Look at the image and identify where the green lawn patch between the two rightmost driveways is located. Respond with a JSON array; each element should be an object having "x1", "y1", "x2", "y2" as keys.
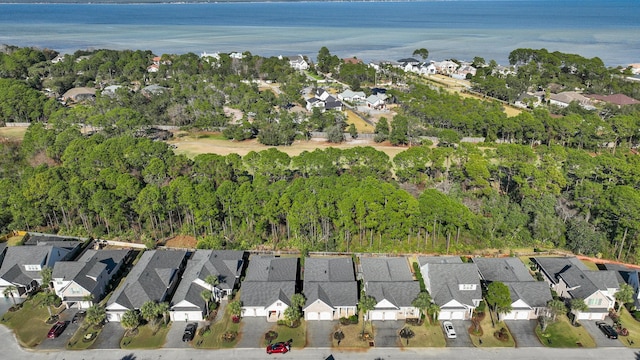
[{"x1": 536, "y1": 315, "x2": 596, "y2": 348}]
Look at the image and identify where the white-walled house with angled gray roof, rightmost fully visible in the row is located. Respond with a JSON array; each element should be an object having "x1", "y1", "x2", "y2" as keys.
[{"x1": 533, "y1": 257, "x2": 620, "y2": 320}]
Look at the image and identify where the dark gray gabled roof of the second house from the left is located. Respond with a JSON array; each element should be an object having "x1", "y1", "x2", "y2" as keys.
[{"x1": 52, "y1": 249, "x2": 130, "y2": 293}]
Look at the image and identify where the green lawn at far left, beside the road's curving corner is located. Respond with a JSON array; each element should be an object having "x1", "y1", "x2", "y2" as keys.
[{"x1": 2, "y1": 293, "x2": 58, "y2": 348}]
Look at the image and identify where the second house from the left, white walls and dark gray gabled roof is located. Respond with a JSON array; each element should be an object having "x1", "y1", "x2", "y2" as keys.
[{"x1": 52, "y1": 249, "x2": 131, "y2": 309}]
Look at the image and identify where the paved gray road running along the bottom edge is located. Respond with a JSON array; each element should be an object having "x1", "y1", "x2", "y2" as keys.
[{"x1": 0, "y1": 326, "x2": 640, "y2": 360}]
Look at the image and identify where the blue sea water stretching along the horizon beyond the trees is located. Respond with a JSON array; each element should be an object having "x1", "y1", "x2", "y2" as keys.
[{"x1": 0, "y1": 0, "x2": 640, "y2": 66}]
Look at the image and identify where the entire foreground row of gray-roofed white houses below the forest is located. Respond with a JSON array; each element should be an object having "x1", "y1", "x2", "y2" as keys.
[{"x1": 0, "y1": 234, "x2": 638, "y2": 322}]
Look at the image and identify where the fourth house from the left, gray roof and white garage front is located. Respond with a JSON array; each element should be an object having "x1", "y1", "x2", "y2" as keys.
[{"x1": 170, "y1": 250, "x2": 246, "y2": 321}]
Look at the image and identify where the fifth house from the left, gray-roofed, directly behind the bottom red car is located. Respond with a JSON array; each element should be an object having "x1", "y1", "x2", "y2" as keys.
[{"x1": 240, "y1": 255, "x2": 299, "y2": 322}]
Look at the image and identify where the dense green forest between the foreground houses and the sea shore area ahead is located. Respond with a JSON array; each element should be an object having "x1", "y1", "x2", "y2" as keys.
[{"x1": 0, "y1": 48, "x2": 640, "y2": 262}]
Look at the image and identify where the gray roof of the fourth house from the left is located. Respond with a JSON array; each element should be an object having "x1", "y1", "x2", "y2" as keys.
[{"x1": 171, "y1": 250, "x2": 245, "y2": 309}]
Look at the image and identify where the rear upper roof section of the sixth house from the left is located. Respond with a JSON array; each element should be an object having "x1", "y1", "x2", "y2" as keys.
[{"x1": 304, "y1": 257, "x2": 356, "y2": 282}]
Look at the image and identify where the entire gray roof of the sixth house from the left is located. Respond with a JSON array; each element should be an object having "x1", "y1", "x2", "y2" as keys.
[{"x1": 303, "y1": 257, "x2": 358, "y2": 308}]
